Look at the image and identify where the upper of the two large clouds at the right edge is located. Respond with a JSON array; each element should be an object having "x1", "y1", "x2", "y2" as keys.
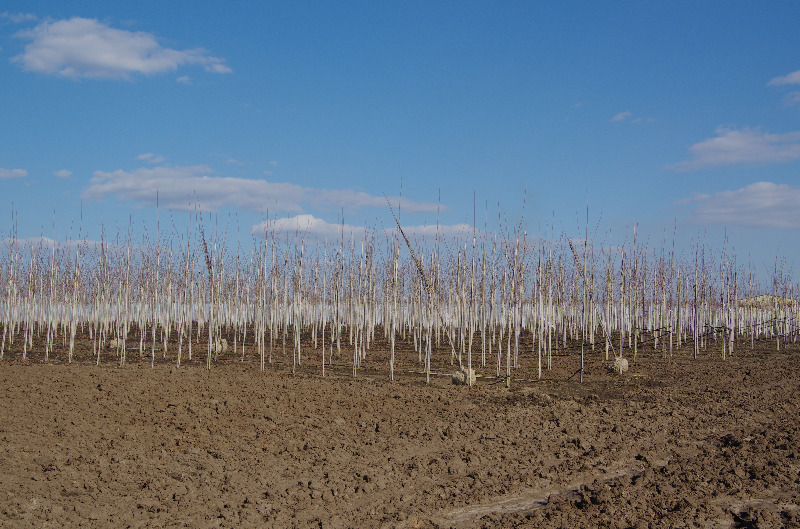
[{"x1": 669, "y1": 127, "x2": 800, "y2": 171}]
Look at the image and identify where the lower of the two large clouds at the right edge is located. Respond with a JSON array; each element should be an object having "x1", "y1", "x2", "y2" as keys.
[{"x1": 691, "y1": 182, "x2": 800, "y2": 229}]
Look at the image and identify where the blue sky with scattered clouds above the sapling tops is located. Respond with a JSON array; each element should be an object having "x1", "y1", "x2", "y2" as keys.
[{"x1": 0, "y1": 1, "x2": 800, "y2": 276}]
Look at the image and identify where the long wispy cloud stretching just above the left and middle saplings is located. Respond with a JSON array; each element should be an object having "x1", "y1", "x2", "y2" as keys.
[{"x1": 83, "y1": 165, "x2": 446, "y2": 214}]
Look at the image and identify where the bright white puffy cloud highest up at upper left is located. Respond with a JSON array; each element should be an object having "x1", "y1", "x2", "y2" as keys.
[{"x1": 11, "y1": 17, "x2": 231, "y2": 79}]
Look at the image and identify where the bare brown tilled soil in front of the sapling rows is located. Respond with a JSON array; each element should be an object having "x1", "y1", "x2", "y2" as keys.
[{"x1": 0, "y1": 328, "x2": 800, "y2": 528}]
